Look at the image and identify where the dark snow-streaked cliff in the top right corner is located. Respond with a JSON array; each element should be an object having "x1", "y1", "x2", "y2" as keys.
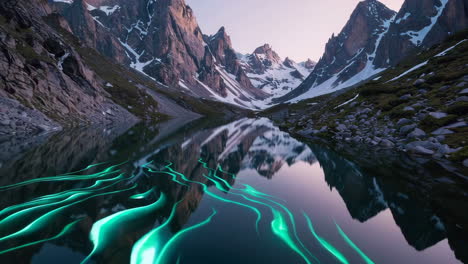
[{"x1": 376, "y1": 0, "x2": 468, "y2": 67}]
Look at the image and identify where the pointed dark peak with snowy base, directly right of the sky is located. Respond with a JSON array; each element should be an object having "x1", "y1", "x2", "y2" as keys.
[{"x1": 281, "y1": 0, "x2": 396, "y2": 100}]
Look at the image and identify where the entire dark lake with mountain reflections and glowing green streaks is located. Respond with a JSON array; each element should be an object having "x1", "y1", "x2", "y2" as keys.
[{"x1": 0, "y1": 119, "x2": 468, "y2": 263}]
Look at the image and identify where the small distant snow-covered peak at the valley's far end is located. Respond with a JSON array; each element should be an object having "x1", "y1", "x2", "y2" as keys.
[{"x1": 239, "y1": 44, "x2": 315, "y2": 100}]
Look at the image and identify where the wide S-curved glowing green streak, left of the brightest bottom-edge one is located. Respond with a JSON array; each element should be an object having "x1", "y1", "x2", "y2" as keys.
[{"x1": 82, "y1": 192, "x2": 167, "y2": 263}]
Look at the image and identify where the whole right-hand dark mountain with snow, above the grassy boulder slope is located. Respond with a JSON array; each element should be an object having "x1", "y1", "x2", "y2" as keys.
[{"x1": 276, "y1": 0, "x2": 468, "y2": 102}]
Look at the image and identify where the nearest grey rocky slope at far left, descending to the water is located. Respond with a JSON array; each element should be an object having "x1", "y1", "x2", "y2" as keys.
[{"x1": 0, "y1": 1, "x2": 137, "y2": 136}]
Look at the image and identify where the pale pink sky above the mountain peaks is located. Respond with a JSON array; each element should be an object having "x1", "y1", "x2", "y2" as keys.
[{"x1": 186, "y1": 0, "x2": 403, "y2": 62}]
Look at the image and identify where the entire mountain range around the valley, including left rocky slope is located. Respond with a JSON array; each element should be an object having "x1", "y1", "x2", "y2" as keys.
[{"x1": 0, "y1": 0, "x2": 468, "y2": 132}]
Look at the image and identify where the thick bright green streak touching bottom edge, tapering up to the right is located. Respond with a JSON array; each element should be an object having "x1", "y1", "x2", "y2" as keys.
[{"x1": 130, "y1": 201, "x2": 182, "y2": 264}]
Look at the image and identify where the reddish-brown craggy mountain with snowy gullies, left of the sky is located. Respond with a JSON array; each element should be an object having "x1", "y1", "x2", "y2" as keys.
[{"x1": 49, "y1": 0, "x2": 267, "y2": 108}]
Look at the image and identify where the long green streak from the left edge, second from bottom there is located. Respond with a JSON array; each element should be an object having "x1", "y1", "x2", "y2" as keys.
[{"x1": 0, "y1": 184, "x2": 137, "y2": 242}]
